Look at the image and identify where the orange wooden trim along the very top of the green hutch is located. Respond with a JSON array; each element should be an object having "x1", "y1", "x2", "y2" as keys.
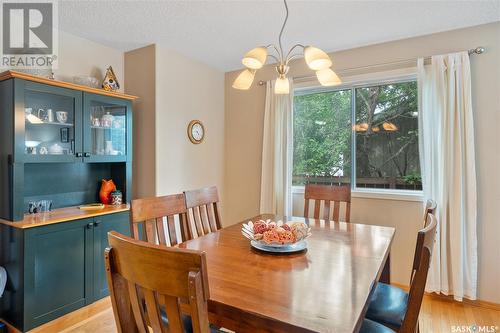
[{"x1": 0, "y1": 71, "x2": 138, "y2": 101}]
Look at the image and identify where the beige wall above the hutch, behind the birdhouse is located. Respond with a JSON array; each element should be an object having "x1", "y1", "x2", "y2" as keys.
[{"x1": 54, "y1": 31, "x2": 125, "y2": 91}]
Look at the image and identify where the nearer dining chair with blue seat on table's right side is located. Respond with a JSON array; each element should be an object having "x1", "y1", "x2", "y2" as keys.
[{"x1": 366, "y1": 214, "x2": 437, "y2": 333}]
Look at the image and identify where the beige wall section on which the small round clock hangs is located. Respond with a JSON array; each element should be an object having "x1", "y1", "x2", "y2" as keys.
[{"x1": 156, "y1": 47, "x2": 224, "y2": 194}]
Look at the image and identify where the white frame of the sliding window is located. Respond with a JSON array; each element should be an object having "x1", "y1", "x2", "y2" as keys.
[{"x1": 291, "y1": 68, "x2": 423, "y2": 201}]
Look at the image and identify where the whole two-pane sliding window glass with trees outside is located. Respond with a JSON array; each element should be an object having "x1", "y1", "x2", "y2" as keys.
[{"x1": 292, "y1": 80, "x2": 422, "y2": 190}]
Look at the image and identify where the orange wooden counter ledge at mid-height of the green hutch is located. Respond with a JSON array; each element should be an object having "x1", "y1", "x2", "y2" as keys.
[{"x1": 0, "y1": 205, "x2": 130, "y2": 229}]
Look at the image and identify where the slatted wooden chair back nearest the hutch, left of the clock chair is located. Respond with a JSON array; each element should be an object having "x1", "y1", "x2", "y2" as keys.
[{"x1": 130, "y1": 193, "x2": 191, "y2": 246}]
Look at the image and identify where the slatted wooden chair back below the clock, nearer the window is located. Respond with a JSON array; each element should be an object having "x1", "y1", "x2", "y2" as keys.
[{"x1": 184, "y1": 186, "x2": 222, "y2": 238}]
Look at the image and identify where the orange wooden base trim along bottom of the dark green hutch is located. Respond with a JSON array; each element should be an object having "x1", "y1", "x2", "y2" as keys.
[{"x1": 0, "y1": 296, "x2": 111, "y2": 333}]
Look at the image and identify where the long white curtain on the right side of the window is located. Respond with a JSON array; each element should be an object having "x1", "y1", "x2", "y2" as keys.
[{"x1": 418, "y1": 52, "x2": 477, "y2": 300}]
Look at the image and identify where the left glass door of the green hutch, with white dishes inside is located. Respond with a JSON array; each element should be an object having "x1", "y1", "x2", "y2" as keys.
[{"x1": 22, "y1": 82, "x2": 82, "y2": 163}]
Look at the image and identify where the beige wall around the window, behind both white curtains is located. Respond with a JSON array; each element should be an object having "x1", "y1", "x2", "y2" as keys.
[{"x1": 224, "y1": 23, "x2": 500, "y2": 303}]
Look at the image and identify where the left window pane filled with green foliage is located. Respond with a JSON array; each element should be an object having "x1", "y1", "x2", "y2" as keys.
[{"x1": 292, "y1": 89, "x2": 352, "y2": 185}]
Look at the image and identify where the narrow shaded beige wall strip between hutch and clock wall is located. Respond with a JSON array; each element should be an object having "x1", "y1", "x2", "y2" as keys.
[{"x1": 125, "y1": 45, "x2": 156, "y2": 198}]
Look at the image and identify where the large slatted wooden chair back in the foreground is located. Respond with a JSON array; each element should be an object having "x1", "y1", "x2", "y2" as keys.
[{"x1": 104, "y1": 231, "x2": 210, "y2": 333}]
